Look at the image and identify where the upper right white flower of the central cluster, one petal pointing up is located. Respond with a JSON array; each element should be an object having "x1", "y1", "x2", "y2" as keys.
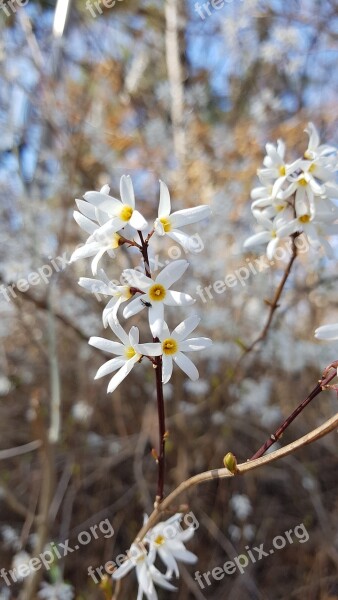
[{"x1": 154, "y1": 181, "x2": 211, "y2": 252}]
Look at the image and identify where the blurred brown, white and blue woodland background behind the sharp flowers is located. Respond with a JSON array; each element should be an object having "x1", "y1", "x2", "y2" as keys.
[{"x1": 0, "y1": 0, "x2": 338, "y2": 600}]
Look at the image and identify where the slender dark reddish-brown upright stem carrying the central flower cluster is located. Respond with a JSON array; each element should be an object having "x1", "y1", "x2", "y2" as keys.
[{"x1": 138, "y1": 231, "x2": 166, "y2": 506}]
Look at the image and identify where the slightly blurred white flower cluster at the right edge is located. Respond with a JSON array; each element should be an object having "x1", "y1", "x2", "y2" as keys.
[{"x1": 244, "y1": 123, "x2": 338, "y2": 260}]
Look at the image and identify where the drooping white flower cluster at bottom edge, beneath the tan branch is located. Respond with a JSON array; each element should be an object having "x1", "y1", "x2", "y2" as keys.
[{"x1": 113, "y1": 513, "x2": 197, "y2": 600}]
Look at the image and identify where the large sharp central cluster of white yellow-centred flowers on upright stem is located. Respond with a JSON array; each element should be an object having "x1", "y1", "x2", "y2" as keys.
[{"x1": 71, "y1": 175, "x2": 211, "y2": 392}]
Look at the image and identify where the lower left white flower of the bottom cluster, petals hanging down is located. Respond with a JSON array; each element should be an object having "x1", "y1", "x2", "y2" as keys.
[{"x1": 112, "y1": 544, "x2": 176, "y2": 600}]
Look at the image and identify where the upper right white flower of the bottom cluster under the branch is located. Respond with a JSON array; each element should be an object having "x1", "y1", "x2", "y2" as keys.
[{"x1": 145, "y1": 513, "x2": 197, "y2": 578}]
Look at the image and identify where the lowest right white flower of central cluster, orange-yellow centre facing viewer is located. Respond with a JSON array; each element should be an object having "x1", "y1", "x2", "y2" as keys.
[{"x1": 159, "y1": 315, "x2": 212, "y2": 383}]
